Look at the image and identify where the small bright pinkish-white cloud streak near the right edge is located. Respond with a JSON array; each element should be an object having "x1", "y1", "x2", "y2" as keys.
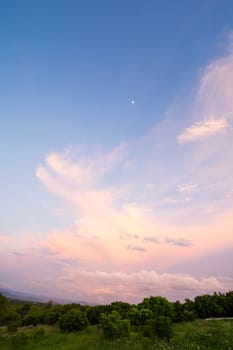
[{"x1": 177, "y1": 118, "x2": 230, "y2": 143}]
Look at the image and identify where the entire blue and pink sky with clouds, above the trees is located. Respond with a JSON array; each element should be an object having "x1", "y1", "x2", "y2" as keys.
[{"x1": 0, "y1": 0, "x2": 233, "y2": 303}]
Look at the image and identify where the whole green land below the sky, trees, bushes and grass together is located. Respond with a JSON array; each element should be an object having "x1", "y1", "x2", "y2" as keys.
[{"x1": 0, "y1": 291, "x2": 233, "y2": 350}]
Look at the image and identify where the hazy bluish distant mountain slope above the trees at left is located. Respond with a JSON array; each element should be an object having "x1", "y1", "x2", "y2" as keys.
[{"x1": 0, "y1": 287, "x2": 88, "y2": 305}]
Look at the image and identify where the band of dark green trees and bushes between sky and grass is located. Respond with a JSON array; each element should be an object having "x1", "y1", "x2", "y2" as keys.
[{"x1": 0, "y1": 291, "x2": 233, "y2": 339}]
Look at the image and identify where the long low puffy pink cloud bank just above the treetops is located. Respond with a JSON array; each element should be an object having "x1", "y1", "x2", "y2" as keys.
[{"x1": 55, "y1": 269, "x2": 225, "y2": 303}]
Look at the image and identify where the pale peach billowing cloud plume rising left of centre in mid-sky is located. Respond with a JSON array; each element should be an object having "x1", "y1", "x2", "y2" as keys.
[{"x1": 37, "y1": 148, "x2": 166, "y2": 256}]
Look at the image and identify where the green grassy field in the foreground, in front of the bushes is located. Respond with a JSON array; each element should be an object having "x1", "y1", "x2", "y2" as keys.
[{"x1": 0, "y1": 320, "x2": 233, "y2": 350}]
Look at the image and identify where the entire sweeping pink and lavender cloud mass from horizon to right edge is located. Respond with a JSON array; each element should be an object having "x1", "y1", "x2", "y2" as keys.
[{"x1": 0, "y1": 36, "x2": 233, "y2": 302}]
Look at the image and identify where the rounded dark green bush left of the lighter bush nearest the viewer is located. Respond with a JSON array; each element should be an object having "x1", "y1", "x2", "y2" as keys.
[{"x1": 59, "y1": 309, "x2": 89, "y2": 332}]
